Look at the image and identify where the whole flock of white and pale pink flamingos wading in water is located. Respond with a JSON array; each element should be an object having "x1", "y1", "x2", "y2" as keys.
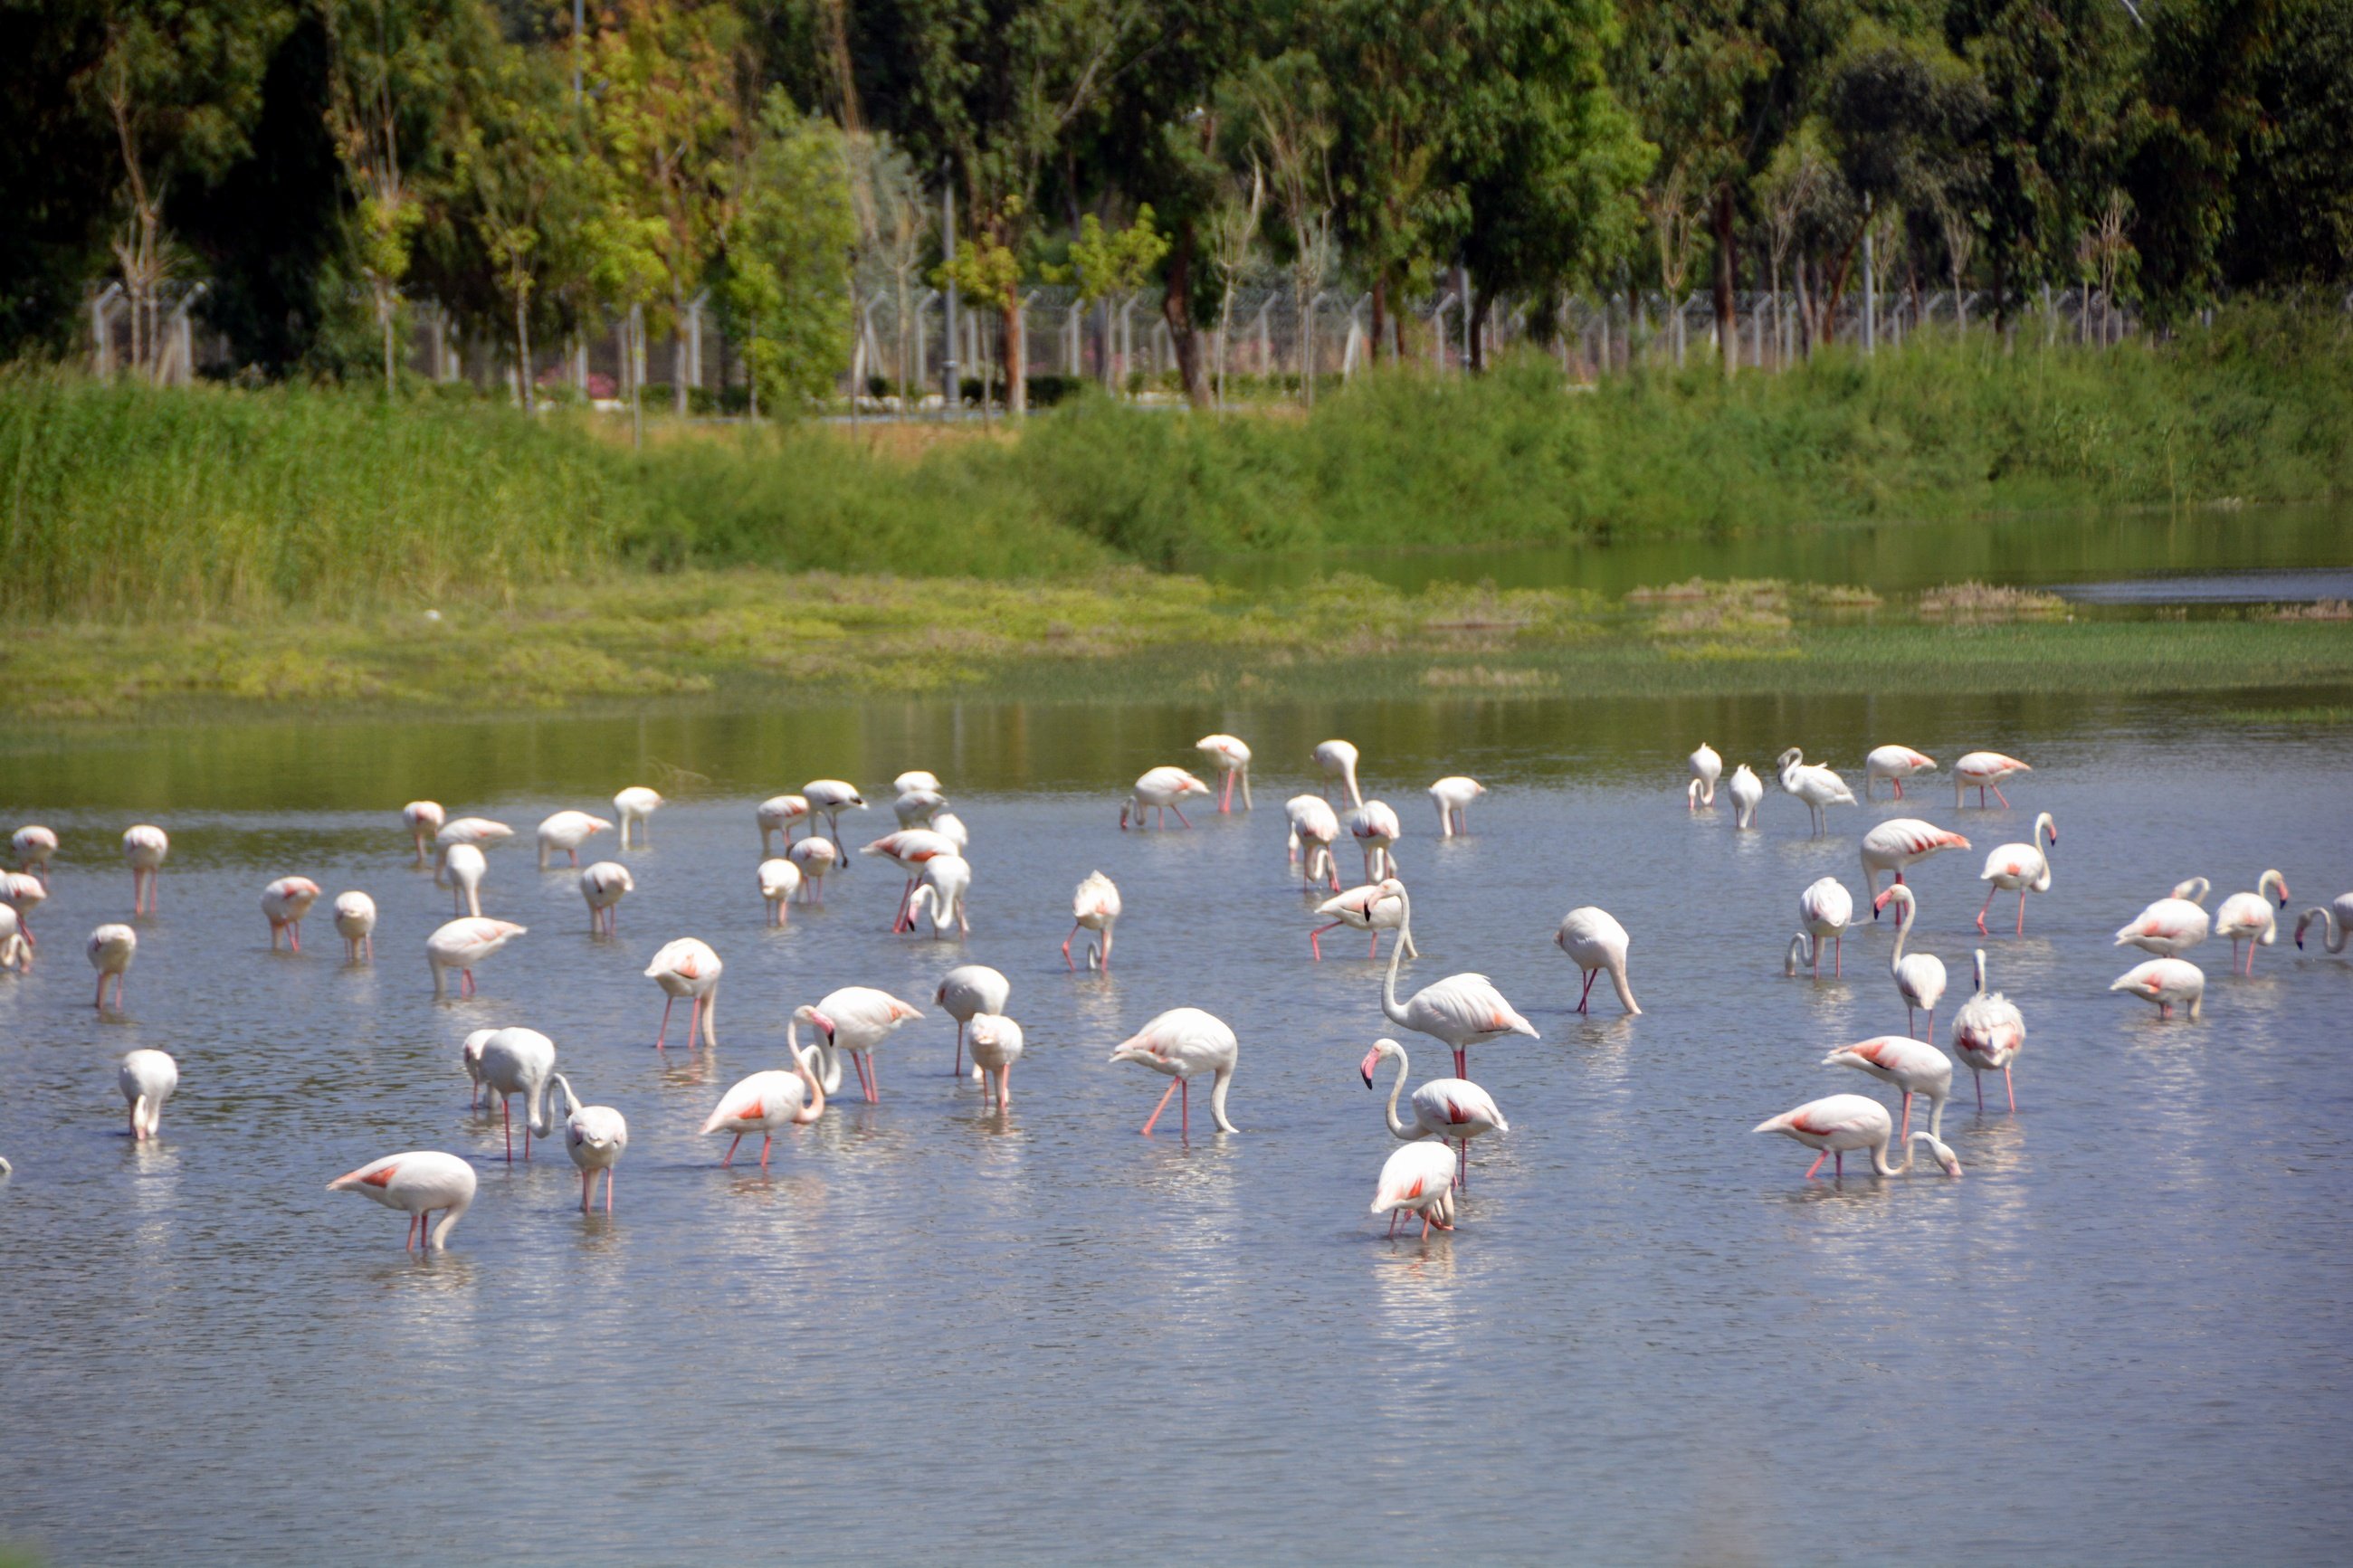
[{"x1": 0, "y1": 736, "x2": 2353, "y2": 1250}]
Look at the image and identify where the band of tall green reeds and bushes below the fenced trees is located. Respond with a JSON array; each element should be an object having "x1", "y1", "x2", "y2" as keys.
[{"x1": 0, "y1": 310, "x2": 2353, "y2": 623}]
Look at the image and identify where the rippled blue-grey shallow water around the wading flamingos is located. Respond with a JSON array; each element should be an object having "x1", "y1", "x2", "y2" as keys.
[{"x1": 0, "y1": 700, "x2": 2353, "y2": 1563}]
